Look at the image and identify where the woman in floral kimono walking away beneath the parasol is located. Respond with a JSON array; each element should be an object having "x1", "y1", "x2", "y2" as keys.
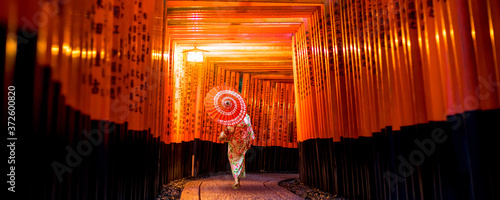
[{"x1": 219, "y1": 114, "x2": 255, "y2": 189}]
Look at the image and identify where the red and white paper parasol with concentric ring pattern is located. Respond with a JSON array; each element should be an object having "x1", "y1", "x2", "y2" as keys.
[{"x1": 205, "y1": 86, "x2": 247, "y2": 126}]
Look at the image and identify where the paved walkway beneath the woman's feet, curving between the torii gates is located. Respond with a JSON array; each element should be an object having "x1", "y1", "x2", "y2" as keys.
[{"x1": 181, "y1": 174, "x2": 301, "y2": 200}]
